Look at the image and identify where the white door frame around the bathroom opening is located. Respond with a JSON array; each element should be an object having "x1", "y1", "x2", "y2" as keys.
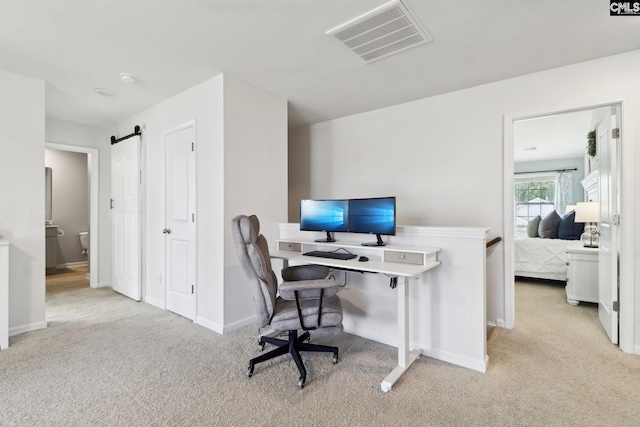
[{"x1": 44, "y1": 141, "x2": 100, "y2": 288}]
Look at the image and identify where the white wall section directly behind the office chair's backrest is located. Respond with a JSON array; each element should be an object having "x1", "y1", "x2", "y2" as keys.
[{"x1": 221, "y1": 78, "x2": 288, "y2": 330}]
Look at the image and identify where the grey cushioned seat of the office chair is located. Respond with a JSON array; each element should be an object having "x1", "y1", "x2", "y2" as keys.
[{"x1": 271, "y1": 296, "x2": 342, "y2": 335}]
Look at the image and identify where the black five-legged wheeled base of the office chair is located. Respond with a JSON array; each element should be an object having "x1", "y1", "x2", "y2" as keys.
[{"x1": 247, "y1": 331, "x2": 338, "y2": 388}]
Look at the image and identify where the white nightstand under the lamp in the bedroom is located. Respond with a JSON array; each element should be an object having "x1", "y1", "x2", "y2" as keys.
[{"x1": 566, "y1": 244, "x2": 598, "y2": 305}]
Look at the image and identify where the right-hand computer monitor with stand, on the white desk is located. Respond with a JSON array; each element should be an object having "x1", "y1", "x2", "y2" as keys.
[{"x1": 349, "y1": 197, "x2": 396, "y2": 246}]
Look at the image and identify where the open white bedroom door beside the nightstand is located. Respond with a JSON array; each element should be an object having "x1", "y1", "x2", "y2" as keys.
[{"x1": 597, "y1": 107, "x2": 620, "y2": 344}]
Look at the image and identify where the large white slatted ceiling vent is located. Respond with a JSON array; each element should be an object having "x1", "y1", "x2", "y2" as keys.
[{"x1": 325, "y1": 0, "x2": 431, "y2": 62}]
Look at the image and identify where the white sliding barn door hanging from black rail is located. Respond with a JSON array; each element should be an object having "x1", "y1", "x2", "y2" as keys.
[{"x1": 111, "y1": 136, "x2": 142, "y2": 301}]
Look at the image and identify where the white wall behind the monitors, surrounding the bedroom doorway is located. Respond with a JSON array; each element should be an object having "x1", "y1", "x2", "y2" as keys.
[{"x1": 289, "y1": 51, "x2": 640, "y2": 343}]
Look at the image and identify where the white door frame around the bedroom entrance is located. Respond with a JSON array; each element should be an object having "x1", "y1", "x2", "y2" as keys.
[{"x1": 499, "y1": 93, "x2": 635, "y2": 353}]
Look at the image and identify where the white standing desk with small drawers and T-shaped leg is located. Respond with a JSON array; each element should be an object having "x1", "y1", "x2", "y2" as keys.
[{"x1": 271, "y1": 239, "x2": 440, "y2": 393}]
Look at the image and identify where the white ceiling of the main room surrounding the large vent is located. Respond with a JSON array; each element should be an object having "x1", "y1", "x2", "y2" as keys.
[{"x1": 0, "y1": 0, "x2": 640, "y2": 128}]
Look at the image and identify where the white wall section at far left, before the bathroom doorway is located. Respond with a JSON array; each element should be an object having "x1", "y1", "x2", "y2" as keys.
[{"x1": 0, "y1": 70, "x2": 46, "y2": 335}]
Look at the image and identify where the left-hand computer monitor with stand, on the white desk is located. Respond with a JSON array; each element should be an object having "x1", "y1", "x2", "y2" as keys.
[{"x1": 300, "y1": 199, "x2": 349, "y2": 242}]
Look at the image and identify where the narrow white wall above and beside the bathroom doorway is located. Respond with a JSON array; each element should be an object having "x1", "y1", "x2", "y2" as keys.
[{"x1": 43, "y1": 118, "x2": 113, "y2": 286}]
